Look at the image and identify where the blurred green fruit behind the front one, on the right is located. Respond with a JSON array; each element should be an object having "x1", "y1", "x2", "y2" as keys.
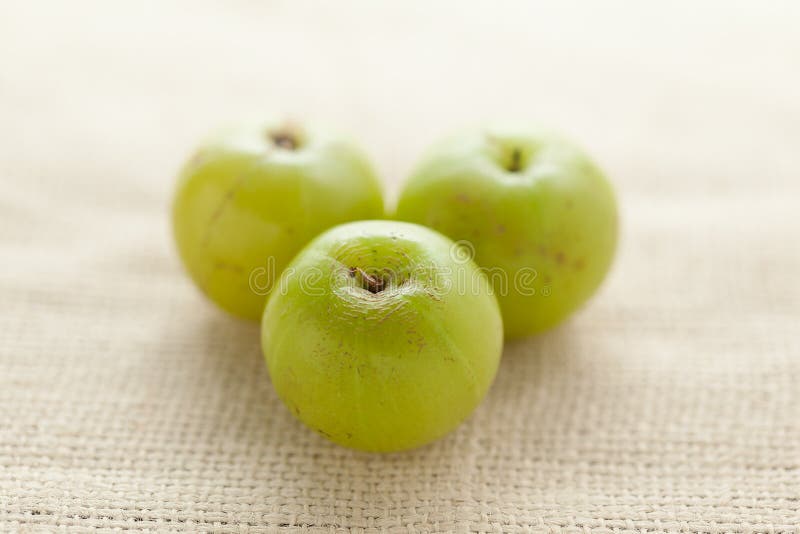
[{"x1": 397, "y1": 129, "x2": 617, "y2": 338}]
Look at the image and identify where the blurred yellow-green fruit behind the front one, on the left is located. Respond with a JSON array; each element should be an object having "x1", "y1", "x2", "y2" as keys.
[{"x1": 172, "y1": 124, "x2": 384, "y2": 320}]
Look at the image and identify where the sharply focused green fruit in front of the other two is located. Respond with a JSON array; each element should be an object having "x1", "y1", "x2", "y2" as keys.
[{"x1": 262, "y1": 221, "x2": 503, "y2": 452}]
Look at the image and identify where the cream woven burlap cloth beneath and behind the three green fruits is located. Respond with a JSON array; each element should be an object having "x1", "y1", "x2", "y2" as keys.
[{"x1": 0, "y1": 1, "x2": 800, "y2": 534}]
